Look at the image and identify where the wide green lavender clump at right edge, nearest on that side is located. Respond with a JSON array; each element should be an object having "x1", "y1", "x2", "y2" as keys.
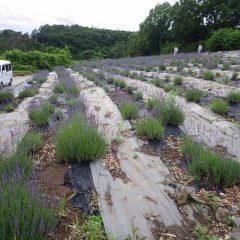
[{"x1": 182, "y1": 136, "x2": 240, "y2": 187}]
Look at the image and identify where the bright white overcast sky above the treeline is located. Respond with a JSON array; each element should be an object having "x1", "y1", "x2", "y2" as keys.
[{"x1": 0, "y1": 0, "x2": 176, "y2": 33}]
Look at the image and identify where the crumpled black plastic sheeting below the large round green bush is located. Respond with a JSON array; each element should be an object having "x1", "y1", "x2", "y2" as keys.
[{"x1": 64, "y1": 162, "x2": 95, "y2": 215}]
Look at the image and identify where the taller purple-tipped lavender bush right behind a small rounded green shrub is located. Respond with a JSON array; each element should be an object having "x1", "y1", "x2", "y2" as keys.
[{"x1": 153, "y1": 98, "x2": 185, "y2": 126}]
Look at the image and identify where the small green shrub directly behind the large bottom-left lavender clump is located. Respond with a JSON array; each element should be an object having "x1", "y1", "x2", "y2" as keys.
[{"x1": 17, "y1": 132, "x2": 43, "y2": 156}]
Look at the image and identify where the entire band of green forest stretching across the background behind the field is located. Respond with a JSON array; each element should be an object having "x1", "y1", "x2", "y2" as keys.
[{"x1": 0, "y1": 0, "x2": 240, "y2": 60}]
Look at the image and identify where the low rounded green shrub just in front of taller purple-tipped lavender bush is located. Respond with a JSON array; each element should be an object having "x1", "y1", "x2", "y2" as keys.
[{"x1": 135, "y1": 118, "x2": 164, "y2": 140}]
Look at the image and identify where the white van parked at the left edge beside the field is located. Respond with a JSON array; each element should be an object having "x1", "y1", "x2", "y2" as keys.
[{"x1": 0, "y1": 60, "x2": 13, "y2": 89}]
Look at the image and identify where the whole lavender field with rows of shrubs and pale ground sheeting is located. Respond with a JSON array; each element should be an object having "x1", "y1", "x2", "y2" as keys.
[{"x1": 0, "y1": 51, "x2": 240, "y2": 240}]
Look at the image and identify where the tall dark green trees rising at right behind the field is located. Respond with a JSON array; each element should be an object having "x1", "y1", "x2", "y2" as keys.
[{"x1": 128, "y1": 0, "x2": 240, "y2": 56}]
